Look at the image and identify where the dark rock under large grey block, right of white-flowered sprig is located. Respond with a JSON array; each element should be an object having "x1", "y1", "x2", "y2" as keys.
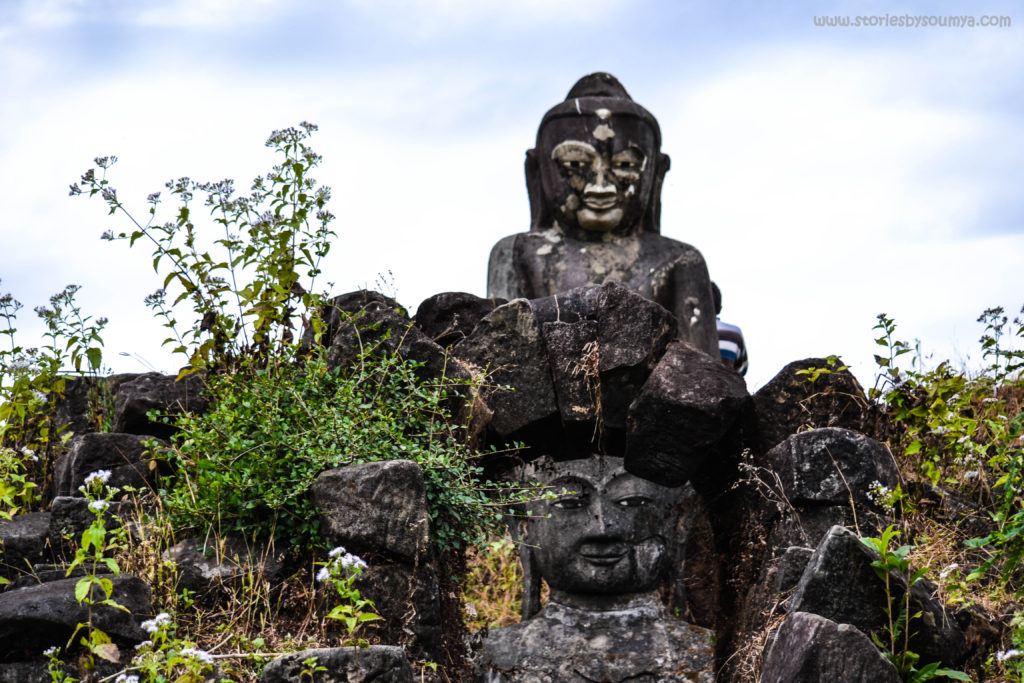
[{"x1": 356, "y1": 560, "x2": 442, "y2": 661}]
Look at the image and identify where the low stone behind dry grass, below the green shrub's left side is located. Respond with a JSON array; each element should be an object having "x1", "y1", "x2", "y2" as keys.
[{"x1": 164, "y1": 535, "x2": 284, "y2": 595}]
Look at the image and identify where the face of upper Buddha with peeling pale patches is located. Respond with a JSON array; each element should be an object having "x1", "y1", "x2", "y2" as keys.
[{"x1": 538, "y1": 113, "x2": 657, "y2": 233}]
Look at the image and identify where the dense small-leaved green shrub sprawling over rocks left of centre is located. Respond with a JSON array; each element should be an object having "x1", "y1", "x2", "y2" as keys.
[{"x1": 166, "y1": 342, "x2": 512, "y2": 548}]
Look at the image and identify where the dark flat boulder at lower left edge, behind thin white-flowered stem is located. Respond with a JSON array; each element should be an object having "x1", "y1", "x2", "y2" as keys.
[{"x1": 0, "y1": 574, "x2": 153, "y2": 660}]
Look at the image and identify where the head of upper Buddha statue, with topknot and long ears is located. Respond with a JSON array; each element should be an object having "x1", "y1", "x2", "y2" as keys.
[{"x1": 526, "y1": 73, "x2": 669, "y2": 238}]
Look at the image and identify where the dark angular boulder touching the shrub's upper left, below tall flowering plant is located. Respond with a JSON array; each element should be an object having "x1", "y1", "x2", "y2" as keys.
[{"x1": 113, "y1": 373, "x2": 210, "y2": 438}]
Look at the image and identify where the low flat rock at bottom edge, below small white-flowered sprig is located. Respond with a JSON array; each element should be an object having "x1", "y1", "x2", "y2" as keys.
[{"x1": 260, "y1": 645, "x2": 413, "y2": 683}]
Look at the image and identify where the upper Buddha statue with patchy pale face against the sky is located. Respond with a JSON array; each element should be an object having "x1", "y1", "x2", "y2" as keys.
[{"x1": 487, "y1": 74, "x2": 719, "y2": 356}]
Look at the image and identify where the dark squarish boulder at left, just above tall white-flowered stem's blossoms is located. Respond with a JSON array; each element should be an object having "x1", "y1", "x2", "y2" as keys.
[{"x1": 53, "y1": 433, "x2": 164, "y2": 496}]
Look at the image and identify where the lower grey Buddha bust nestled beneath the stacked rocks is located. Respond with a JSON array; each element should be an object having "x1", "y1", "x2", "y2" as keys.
[{"x1": 478, "y1": 456, "x2": 714, "y2": 683}]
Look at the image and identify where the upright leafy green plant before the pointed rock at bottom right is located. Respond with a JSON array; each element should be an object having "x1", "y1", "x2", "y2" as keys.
[{"x1": 860, "y1": 524, "x2": 971, "y2": 683}]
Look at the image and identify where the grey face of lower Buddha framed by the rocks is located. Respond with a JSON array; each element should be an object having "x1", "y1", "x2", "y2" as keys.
[{"x1": 526, "y1": 456, "x2": 678, "y2": 595}]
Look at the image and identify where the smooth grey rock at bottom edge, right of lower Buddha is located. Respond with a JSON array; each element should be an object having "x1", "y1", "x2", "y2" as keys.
[{"x1": 761, "y1": 612, "x2": 902, "y2": 683}]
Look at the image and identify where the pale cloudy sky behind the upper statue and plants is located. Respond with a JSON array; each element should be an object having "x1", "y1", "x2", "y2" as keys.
[{"x1": 0, "y1": 0, "x2": 1024, "y2": 390}]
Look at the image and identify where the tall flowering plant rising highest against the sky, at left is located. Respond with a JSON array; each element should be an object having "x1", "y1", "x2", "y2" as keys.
[{"x1": 71, "y1": 123, "x2": 334, "y2": 369}]
